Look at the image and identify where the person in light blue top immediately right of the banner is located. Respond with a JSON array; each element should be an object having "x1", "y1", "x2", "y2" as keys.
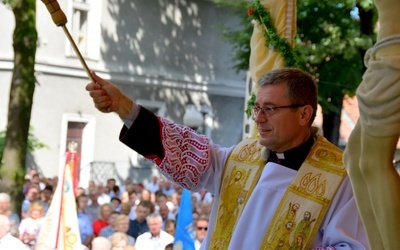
[{"x1": 76, "y1": 194, "x2": 94, "y2": 247}]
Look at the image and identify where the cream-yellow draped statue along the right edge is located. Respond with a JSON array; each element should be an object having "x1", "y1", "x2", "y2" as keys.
[{"x1": 345, "y1": 0, "x2": 400, "y2": 249}]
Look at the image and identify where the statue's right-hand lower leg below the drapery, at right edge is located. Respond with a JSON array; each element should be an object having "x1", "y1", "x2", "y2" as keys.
[{"x1": 360, "y1": 130, "x2": 400, "y2": 249}]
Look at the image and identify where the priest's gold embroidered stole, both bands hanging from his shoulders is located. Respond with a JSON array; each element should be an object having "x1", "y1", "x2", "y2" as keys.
[{"x1": 210, "y1": 130, "x2": 346, "y2": 249}]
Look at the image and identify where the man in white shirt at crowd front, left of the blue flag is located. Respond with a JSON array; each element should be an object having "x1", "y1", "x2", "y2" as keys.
[{"x1": 135, "y1": 213, "x2": 174, "y2": 250}]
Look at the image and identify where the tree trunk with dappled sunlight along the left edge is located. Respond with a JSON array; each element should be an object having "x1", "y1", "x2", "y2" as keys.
[{"x1": 0, "y1": 0, "x2": 37, "y2": 211}]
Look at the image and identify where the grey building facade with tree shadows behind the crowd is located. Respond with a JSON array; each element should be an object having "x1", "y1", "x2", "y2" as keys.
[{"x1": 0, "y1": 0, "x2": 246, "y2": 187}]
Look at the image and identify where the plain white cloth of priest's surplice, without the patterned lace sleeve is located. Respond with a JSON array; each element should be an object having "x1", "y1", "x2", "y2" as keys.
[{"x1": 188, "y1": 144, "x2": 369, "y2": 250}]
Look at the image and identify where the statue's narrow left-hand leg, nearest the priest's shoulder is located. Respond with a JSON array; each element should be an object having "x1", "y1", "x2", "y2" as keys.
[{"x1": 344, "y1": 122, "x2": 384, "y2": 250}]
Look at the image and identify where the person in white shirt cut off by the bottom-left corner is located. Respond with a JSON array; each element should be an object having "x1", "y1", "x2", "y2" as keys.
[{"x1": 0, "y1": 214, "x2": 29, "y2": 250}]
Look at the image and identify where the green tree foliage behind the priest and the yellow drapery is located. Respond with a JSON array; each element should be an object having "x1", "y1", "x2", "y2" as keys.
[{"x1": 219, "y1": 0, "x2": 376, "y2": 144}]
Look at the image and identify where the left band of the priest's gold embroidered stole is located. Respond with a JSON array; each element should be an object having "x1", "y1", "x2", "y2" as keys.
[{"x1": 210, "y1": 139, "x2": 268, "y2": 249}]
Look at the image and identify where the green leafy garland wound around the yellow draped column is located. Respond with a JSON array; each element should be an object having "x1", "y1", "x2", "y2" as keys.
[{"x1": 245, "y1": 0, "x2": 297, "y2": 117}]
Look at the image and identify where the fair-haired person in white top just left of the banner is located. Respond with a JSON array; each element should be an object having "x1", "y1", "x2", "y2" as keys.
[{"x1": 18, "y1": 201, "x2": 44, "y2": 249}]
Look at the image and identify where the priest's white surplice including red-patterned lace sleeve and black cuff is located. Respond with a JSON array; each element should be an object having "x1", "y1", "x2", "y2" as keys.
[{"x1": 120, "y1": 114, "x2": 369, "y2": 250}]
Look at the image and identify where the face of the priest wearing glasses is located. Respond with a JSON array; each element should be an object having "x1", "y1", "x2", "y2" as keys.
[{"x1": 253, "y1": 83, "x2": 310, "y2": 153}]
